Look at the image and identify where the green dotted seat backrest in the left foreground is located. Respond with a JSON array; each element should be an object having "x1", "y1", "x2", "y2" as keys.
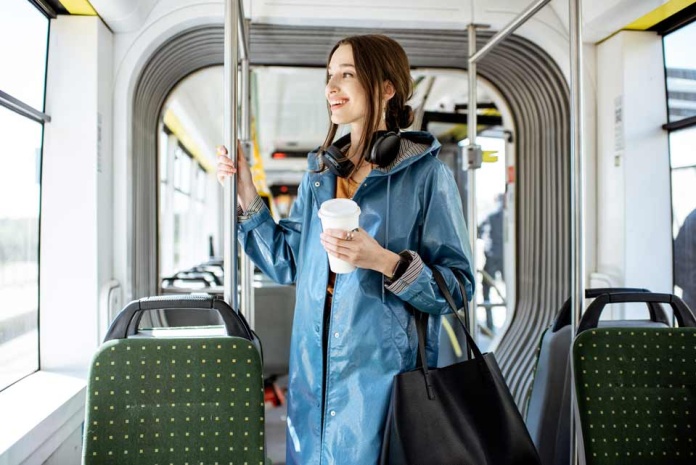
[{"x1": 83, "y1": 297, "x2": 266, "y2": 465}]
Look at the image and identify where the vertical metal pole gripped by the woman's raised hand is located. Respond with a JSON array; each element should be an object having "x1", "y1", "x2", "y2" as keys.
[{"x1": 223, "y1": 0, "x2": 240, "y2": 310}]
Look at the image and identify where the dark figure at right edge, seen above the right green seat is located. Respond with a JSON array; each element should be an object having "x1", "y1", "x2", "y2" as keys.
[{"x1": 674, "y1": 209, "x2": 696, "y2": 311}]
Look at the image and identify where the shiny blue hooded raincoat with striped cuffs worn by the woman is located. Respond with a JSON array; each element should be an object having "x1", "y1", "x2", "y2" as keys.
[{"x1": 239, "y1": 132, "x2": 473, "y2": 465}]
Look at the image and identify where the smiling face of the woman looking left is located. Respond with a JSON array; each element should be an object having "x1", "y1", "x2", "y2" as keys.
[{"x1": 325, "y1": 44, "x2": 367, "y2": 130}]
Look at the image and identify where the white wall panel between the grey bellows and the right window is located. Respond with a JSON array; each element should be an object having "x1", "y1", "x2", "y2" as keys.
[{"x1": 596, "y1": 31, "x2": 672, "y2": 302}]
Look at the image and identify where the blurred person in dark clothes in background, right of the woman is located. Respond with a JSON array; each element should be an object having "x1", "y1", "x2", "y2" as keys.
[{"x1": 477, "y1": 194, "x2": 505, "y2": 331}]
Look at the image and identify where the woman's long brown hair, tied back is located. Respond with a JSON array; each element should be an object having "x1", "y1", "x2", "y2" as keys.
[{"x1": 321, "y1": 34, "x2": 413, "y2": 171}]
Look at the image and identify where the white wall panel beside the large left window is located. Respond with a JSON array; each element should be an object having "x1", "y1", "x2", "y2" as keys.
[{"x1": 40, "y1": 16, "x2": 112, "y2": 371}]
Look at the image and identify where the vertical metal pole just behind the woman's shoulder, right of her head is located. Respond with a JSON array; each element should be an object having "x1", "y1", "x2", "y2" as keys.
[{"x1": 466, "y1": 23, "x2": 481, "y2": 341}]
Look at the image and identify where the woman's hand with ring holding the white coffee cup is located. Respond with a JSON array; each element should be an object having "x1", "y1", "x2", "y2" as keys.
[{"x1": 321, "y1": 228, "x2": 399, "y2": 278}]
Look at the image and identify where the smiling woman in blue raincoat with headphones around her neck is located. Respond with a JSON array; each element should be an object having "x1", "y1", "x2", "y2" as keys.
[{"x1": 218, "y1": 35, "x2": 474, "y2": 465}]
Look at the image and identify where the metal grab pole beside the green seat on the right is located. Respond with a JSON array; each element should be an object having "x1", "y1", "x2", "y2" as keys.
[{"x1": 570, "y1": 0, "x2": 585, "y2": 464}]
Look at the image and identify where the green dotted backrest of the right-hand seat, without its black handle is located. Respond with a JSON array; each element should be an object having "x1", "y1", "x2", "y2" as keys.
[{"x1": 573, "y1": 327, "x2": 696, "y2": 465}]
